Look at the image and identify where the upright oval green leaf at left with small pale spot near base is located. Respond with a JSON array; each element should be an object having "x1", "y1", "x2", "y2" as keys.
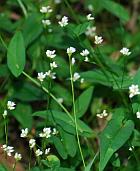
[{"x1": 7, "y1": 32, "x2": 25, "y2": 77}]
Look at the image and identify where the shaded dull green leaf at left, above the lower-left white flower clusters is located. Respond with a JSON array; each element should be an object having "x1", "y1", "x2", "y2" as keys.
[{"x1": 12, "y1": 103, "x2": 32, "y2": 128}]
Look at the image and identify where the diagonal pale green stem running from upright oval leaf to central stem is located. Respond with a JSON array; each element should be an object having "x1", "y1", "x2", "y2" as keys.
[{"x1": 22, "y1": 71, "x2": 74, "y2": 122}]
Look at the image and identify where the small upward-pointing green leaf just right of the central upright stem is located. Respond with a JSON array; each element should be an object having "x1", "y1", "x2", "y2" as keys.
[{"x1": 75, "y1": 87, "x2": 93, "y2": 117}]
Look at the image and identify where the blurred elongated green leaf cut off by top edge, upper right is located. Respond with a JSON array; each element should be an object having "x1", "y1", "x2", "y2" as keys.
[{"x1": 102, "y1": 0, "x2": 130, "y2": 22}]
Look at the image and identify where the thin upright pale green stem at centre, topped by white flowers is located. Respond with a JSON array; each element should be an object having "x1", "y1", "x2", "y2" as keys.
[{"x1": 68, "y1": 54, "x2": 86, "y2": 168}]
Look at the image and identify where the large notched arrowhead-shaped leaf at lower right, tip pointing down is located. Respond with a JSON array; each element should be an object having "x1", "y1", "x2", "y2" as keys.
[{"x1": 99, "y1": 109, "x2": 134, "y2": 171}]
